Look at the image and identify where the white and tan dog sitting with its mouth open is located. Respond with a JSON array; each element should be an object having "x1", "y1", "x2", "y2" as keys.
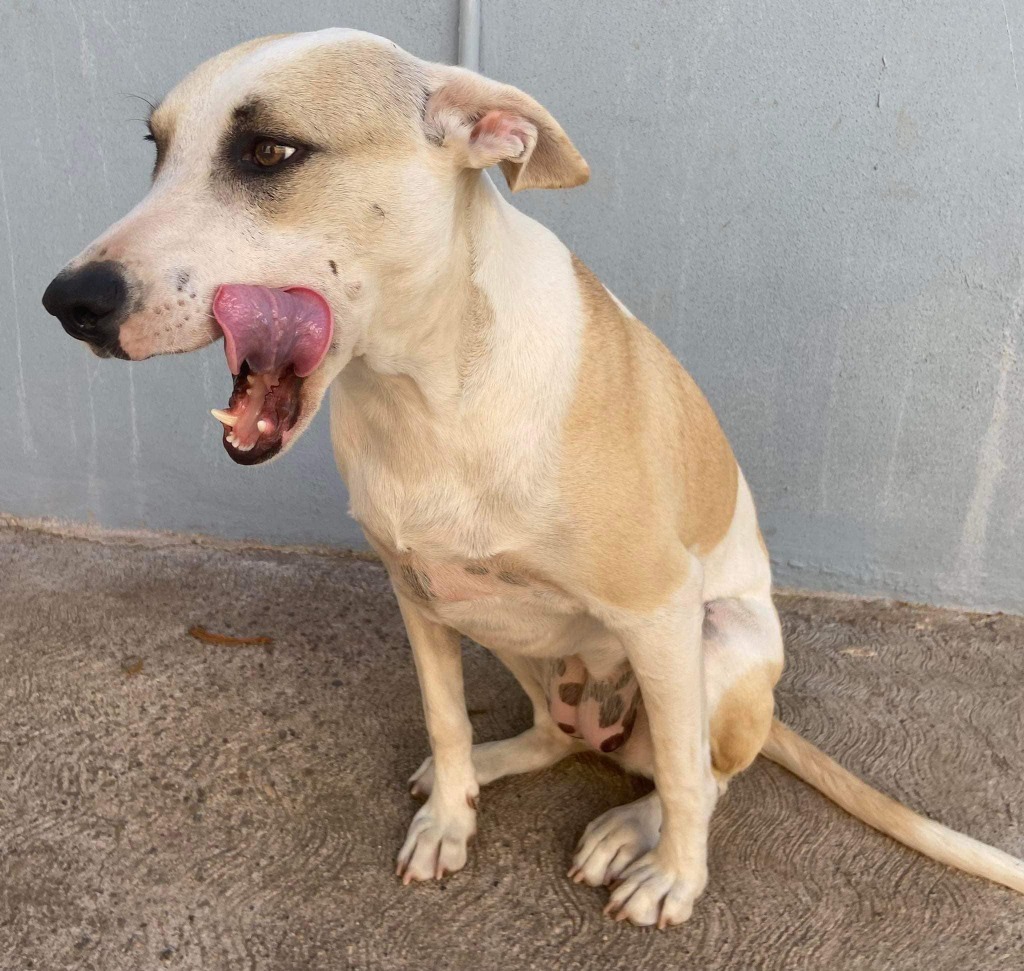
[{"x1": 43, "y1": 30, "x2": 1024, "y2": 927}]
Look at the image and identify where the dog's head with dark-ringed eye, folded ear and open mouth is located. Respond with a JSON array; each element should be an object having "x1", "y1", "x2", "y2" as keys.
[{"x1": 43, "y1": 30, "x2": 589, "y2": 465}]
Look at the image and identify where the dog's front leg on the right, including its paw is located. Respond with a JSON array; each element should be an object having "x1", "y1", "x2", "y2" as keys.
[{"x1": 605, "y1": 562, "x2": 718, "y2": 927}]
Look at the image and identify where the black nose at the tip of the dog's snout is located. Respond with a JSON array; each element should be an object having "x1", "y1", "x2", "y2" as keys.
[{"x1": 43, "y1": 261, "x2": 128, "y2": 356}]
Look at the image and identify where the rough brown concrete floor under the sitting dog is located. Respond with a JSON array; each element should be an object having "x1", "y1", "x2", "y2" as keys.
[{"x1": 0, "y1": 529, "x2": 1024, "y2": 971}]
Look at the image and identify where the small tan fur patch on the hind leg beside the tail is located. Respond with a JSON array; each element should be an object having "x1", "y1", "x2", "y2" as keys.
[{"x1": 711, "y1": 662, "x2": 782, "y2": 778}]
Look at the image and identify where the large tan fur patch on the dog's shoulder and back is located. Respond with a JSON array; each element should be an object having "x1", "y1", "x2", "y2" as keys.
[{"x1": 560, "y1": 257, "x2": 738, "y2": 609}]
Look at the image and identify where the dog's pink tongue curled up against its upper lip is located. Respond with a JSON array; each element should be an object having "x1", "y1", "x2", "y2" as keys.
[{"x1": 213, "y1": 284, "x2": 334, "y2": 378}]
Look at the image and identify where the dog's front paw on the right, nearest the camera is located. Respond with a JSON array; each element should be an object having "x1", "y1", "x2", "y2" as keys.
[{"x1": 604, "y1": 849, "x2": 708, "y2": 929}]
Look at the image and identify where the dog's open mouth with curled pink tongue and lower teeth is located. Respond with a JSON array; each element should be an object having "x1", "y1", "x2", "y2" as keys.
[{"x1": 211, "y1": 284, "x2": 334, "y2": 465}]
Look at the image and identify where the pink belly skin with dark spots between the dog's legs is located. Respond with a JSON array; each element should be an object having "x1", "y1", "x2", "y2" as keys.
[{"x1": 548, "y1": 655, "x2": 641, "y2": 753}]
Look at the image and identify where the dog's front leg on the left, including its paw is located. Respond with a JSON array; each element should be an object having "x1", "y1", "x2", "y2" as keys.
[{"x1": 397, "y1": 594, "x2": 479, "y2": 884}]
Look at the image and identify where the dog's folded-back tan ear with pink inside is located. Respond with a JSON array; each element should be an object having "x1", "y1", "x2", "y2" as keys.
[{"x1": 424, "y1": 68, "x2": 590, "y2": 192}]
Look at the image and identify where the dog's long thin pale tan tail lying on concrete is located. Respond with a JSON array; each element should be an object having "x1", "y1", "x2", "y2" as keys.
[{"x1": 761, "y1": 718, "x2": 1024, "y2": 893}]
